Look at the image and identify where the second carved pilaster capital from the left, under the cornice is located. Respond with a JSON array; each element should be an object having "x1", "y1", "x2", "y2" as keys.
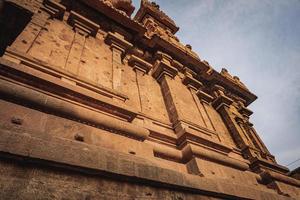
[{"x1": 68, "y1": 11, "x2": 99, "y2": 37}]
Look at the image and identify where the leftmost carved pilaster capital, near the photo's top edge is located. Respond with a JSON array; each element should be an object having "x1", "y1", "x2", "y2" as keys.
[{"x1": 43, "y1": 0, "x2": 66, "y2": 20}]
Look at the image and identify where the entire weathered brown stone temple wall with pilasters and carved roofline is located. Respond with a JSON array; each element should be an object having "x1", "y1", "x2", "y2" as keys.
[{"x1": 0, "y1": 0, "x2": 300, "y2": 200}]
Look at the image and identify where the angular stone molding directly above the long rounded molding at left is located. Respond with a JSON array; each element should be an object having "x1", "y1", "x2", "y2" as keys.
[{"x1": 0, "y1": 58, "x2": 137, "y2": 121}]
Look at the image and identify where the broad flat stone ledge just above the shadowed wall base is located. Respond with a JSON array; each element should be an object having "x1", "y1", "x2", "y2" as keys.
[{"x1": 0, "y1": 130, "x2": 291, "y2": 200}]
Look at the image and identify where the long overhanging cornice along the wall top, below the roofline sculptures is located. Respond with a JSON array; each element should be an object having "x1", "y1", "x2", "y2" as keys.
[{"x1": 81, "y1": 0, "x2": 257, "y2": 108}]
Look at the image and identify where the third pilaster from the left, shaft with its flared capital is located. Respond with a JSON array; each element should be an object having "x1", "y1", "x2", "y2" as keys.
[{"x1": 105, "y1": 32, "x2": 132, "y2": 90}]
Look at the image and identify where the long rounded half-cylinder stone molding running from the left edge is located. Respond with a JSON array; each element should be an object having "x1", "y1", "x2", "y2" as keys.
[{"x1": 0, "y1": 80, "x2": 150, "y2": 140}]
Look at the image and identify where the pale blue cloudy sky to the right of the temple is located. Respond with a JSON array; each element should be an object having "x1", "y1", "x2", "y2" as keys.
[{"x1": 133, "y1": 0, "x2": 300, "y2": 169}]
